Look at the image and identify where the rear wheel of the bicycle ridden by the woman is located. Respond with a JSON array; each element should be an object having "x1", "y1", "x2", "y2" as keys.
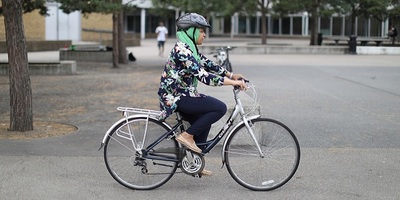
[{"x1": 104, "y1": 117, "x2": 179, "y2": 190}]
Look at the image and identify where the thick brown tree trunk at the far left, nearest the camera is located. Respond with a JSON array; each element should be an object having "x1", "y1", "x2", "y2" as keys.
[{"x1": 2, "y1": 0, "x2": 33, "y2": 131}]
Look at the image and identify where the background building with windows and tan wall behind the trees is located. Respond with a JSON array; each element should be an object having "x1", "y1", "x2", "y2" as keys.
[{"x1": 0, "y1": 0, "x2": 400, "y2": 42}]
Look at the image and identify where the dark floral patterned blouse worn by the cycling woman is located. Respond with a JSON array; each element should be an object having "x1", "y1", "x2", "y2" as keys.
[{"x1": 158, "y1": 41, "x2": 228, "y2": 120}]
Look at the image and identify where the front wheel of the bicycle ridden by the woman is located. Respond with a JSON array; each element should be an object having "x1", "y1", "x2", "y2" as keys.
[{"x1": 224, "y1": 118, "x2": 300, "y2": 191}]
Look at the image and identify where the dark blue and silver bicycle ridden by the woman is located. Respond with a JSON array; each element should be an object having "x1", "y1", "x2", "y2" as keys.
[{"x1": 99, "y1": 81, "x2": 300, "y2": 191}]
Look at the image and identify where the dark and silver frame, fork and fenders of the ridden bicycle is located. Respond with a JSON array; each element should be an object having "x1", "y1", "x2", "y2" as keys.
[{"x1": 99, "y1": 88, "x2": 264, "y2": 163}]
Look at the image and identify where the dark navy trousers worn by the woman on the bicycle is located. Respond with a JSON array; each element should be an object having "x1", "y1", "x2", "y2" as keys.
[{"x1": 177, "y1": 96, "x2": 227, "y2": 148}]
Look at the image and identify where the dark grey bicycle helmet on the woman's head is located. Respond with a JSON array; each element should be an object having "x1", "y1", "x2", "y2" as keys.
[{"x1": 176, "y1": 13, "x2": 211, "y2": 30}]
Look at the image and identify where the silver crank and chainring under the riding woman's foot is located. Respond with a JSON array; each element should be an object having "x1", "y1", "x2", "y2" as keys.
[{"x1": 180, "y1": 150, "x2": 205, "y2": 177}]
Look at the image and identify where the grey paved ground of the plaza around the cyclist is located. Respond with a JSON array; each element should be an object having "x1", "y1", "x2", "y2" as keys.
[{"x1": 0, "y1": 40, "x2": 400, "y2": 199}]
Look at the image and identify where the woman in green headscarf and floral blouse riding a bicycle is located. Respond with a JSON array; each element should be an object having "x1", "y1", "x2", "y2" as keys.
[{"x1": 158, "y1": 13, "x2": 246, "y2": 175}]
